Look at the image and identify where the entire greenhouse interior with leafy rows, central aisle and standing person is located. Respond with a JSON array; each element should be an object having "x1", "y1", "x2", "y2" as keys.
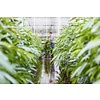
[{"x1": 0, "y1": 17, "x2": 100, "y2": 84}]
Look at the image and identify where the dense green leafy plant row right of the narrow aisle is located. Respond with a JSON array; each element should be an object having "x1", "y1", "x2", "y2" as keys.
[{"x1": 53, "y1": 17, "x2": 100, "y2": 84}]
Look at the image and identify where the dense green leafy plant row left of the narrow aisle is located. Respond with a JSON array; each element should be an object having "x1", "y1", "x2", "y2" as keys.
[{"x1": 0, "y1": 17, "x2": 42, "y2": 84}]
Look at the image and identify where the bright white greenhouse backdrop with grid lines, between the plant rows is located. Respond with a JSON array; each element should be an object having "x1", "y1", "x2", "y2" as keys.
[{"x1": 25, "y1": 17, "x2": 70, "y2": 37}]
